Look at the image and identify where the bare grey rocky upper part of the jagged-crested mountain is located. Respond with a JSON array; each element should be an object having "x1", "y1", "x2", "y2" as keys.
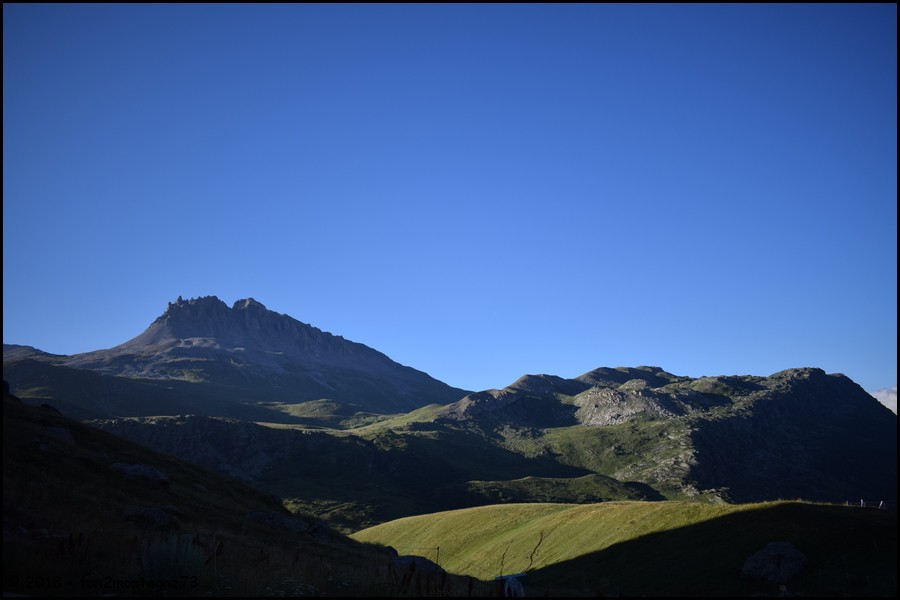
[{"x1": 45, "y1": 296, "x2": 467, "y2": 412}]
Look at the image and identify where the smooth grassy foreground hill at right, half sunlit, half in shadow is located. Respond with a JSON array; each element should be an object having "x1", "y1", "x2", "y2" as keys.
[{"x1": 352, "y1": 502, "x2": 897, "y2": 595}]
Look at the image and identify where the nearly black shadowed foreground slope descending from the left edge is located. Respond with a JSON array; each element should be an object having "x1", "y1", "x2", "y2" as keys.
[{"x1": 3, "y1": 384, "x2": 495, "y2": 597}]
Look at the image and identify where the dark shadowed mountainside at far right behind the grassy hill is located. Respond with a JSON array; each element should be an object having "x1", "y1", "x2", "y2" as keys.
[{"x1": 690, "y1": 369, "x2": 897, "y2": 502}]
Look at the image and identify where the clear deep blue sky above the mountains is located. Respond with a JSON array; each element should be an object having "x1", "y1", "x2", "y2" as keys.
[{"x1": 3, "y1": 4, "x2": 897, "y2": 391}]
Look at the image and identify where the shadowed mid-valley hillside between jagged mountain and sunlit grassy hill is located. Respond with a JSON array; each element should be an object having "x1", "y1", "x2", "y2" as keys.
[{"x1": 89, "y1": 416, "x2": 662, "y2": 530}]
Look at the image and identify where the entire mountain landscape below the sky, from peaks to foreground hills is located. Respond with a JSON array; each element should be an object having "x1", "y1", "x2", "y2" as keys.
[{"x1": 3, "y1": 296, "x2": 897, "y2": 596}]
